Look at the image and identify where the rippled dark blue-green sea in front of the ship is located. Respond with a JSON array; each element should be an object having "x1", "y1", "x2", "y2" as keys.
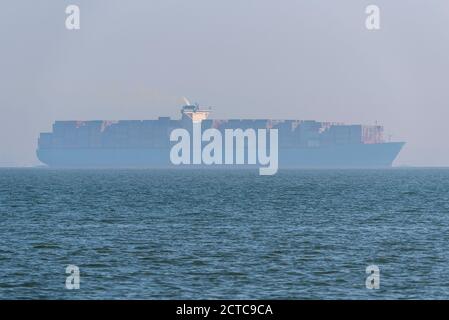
[{"x1": 0, "y1": 169, "x2": 449, "y2": 299}]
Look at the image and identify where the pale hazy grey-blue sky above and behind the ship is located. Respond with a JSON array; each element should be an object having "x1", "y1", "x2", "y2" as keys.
[{"x1": 0, "y1": 0, "x2": 449, "y2": 166}]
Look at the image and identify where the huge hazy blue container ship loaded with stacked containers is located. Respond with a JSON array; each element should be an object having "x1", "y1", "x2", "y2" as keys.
[{"x1": 37, "y1": 103, "x2": 405, "y2": 168}]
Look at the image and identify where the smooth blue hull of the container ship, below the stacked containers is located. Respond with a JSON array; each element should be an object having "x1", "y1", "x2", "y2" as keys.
[{"x1": 37, "y1": 142, "x2": 404, "y2": 168}]
